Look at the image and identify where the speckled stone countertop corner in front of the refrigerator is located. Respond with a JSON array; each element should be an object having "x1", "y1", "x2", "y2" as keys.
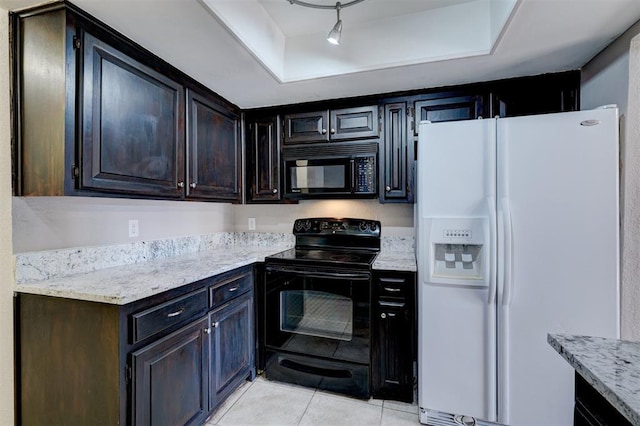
[{"x1": 547, "y1": 334, "x2": 640, "y2": 425}]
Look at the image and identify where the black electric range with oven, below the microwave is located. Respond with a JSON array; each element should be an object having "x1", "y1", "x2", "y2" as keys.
[{"x1": 263, "y1": 218, "x2": 381, "y2": 398}]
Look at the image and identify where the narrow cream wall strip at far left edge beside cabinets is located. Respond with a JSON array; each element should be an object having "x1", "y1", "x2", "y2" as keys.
[{"x1": 0, "y1": 9, "x2": 14, "y2": 425}]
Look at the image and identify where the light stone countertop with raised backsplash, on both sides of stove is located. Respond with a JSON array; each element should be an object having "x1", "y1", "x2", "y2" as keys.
[{"x1": 14, "y1": 234, "x2": 416, "y2": 305}]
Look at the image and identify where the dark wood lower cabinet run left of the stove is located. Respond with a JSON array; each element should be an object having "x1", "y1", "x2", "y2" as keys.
[{"x1": 15, "y1": 266, "x2": 255, "y2": 425}]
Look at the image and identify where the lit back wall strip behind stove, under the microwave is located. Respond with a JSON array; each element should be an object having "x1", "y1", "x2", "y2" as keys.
[{"x1": 233, "y1": 199, "x2": 414, "y2": 237}]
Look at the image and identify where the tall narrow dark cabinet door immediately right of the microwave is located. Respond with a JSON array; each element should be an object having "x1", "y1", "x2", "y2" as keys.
[{"x1": 380, "y1": 102, "x2": 414, "y2": 202}]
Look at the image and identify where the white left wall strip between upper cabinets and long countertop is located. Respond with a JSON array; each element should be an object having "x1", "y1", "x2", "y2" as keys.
[{"x1": 12, "y1": 197, "x2": 234, "y2": 253}]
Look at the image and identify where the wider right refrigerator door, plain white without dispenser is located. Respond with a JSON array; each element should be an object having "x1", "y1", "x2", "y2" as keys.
[{"x1": 497, "y1": 109, "x2": 619, "y2": 425}]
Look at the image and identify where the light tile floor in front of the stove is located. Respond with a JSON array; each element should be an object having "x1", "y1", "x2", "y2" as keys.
[{"x1": 206, "y1": 376, "x2": 420, "y2": 426}]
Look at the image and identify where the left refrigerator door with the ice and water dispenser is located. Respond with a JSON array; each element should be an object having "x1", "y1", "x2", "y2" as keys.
[{"x1": 416, "y1": 119, "x2": 497, "y2": 423}]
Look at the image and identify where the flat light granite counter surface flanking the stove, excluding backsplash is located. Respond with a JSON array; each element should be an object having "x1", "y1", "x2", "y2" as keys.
[{"x1": 14, "y1": 245, "x2": 417, "y2": 305}]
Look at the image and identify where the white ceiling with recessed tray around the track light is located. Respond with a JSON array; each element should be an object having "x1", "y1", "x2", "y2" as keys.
[{"x1": 0, "y1": 0, "x2": 640, "y2": 108}]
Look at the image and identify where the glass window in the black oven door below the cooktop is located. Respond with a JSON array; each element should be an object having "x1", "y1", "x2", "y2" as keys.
[{"x1": 280, "y1": 290, "x2": 353, "y2": 341}]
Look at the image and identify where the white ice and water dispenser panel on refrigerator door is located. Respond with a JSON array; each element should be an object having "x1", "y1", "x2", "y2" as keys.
[{"x1": 428, "y1": 218, "x2": 489, "y2": 286}]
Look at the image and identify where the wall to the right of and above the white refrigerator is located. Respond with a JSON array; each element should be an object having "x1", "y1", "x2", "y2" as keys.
[{"x1": 580, "y1": 22, "x2": 640, "y2": 341}]
